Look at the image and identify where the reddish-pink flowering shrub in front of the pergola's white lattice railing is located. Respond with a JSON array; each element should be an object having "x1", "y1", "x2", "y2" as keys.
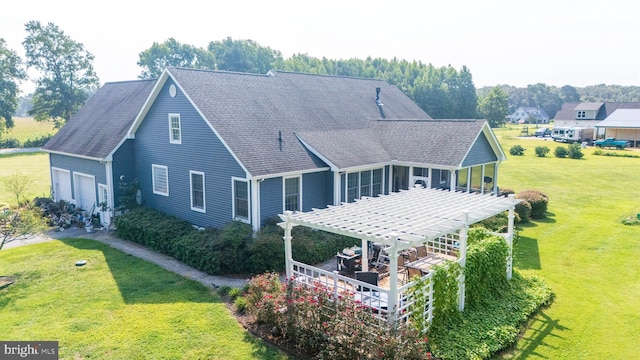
[{"x1": 245, "y1": 273, "x2": 431, "y2": 359}]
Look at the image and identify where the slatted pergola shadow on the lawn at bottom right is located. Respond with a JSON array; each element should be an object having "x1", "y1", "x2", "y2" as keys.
[{"x1": 513, "y1": 311, "x2": 569, "y2": 360}]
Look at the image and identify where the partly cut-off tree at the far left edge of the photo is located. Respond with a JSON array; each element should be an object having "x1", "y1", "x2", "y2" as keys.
[{"x1": 0, "y1": 38, "x2": 27, "y2": 134}]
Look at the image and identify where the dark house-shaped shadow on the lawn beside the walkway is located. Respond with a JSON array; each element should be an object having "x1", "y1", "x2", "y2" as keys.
[{"x1": 60, "y1": 238, "x2": 222, "y2": 304}]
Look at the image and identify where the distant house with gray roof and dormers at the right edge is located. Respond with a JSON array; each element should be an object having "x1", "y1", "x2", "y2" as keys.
[{"x1": 553, "y1": 102, "x2": 640, "y2": 137}]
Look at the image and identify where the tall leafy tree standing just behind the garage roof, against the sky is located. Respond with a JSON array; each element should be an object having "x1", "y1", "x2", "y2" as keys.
[{"x1": 22, "y1": 21, "x2": 100, "y2": 128}]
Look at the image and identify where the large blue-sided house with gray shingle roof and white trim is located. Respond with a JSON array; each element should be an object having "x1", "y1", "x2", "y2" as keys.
[{"x1": 44, "y1": 68, "x2": 506, "y2": 230}]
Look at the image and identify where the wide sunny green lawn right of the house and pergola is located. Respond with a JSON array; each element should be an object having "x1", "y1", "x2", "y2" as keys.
[{"x1": 497, "y1": 126, "x2": 640, "y2": 359}]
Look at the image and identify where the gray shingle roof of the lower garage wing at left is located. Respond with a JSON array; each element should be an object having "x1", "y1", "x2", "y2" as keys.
[{"x1": 43, "y1": 80, "x2": 156, "y2": 159}]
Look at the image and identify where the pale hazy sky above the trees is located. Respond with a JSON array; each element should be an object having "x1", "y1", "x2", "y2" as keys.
[{"x1": 5, "y1": 0, "x2": 640, "y2": 92}]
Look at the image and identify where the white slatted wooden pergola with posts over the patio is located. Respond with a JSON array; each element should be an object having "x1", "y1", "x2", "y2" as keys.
[{"x1": 279, "y1": 188, "x2": 519, "y2": 320}]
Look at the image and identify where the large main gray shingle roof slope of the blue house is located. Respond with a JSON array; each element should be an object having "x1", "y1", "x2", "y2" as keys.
[{"x1": 169, "y1": 68, "x2": 431, "y2": 176}]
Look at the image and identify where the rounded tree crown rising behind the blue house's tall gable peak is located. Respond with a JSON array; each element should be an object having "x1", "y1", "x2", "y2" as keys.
[{"x1": 138, "y1": 38, "x2": 216, "y2": 79}]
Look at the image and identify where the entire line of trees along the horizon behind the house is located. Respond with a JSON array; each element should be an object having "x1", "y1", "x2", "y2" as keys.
[{"x1": 0, "y1": 21, "x2": 640, "y2": 135}]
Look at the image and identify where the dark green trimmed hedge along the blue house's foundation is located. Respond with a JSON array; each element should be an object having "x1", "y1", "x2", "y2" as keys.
[{"x1": 115, "y1": 208, "x2": 360, "y2": 275}]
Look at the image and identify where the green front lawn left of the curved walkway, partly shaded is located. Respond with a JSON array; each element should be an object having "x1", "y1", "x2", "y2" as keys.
[{"x1": 0, "y1": 239, "x2": 287, "y2": 360}]
